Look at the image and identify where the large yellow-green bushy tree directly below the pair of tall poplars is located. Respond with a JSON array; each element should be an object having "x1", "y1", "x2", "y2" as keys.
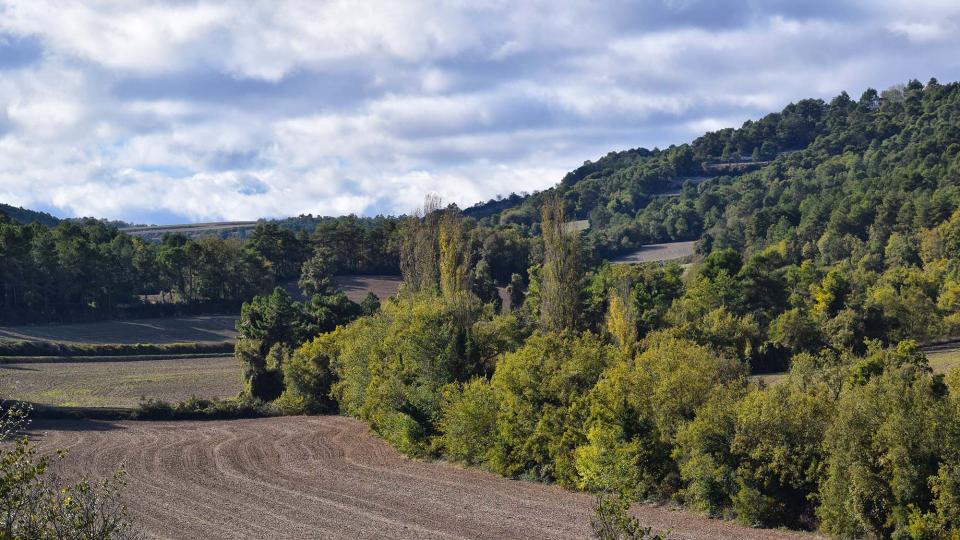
[{"x1": 332, "y1": 295, "x2": 490, "y2": 455}]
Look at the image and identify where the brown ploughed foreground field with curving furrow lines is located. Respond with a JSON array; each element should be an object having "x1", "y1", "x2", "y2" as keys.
[{"x1": 33, "y1": 416, "x2": 812, "y2": 539}]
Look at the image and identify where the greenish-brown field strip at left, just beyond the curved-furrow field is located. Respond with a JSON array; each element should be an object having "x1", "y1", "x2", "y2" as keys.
[{"x1": 0, "y1": 356, "x2": 241, "y2": 407}]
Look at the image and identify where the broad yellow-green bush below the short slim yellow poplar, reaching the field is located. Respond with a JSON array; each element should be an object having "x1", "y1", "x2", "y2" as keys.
[{"x1": 574, "y1": 335, "x2": 745, "y2": 497}]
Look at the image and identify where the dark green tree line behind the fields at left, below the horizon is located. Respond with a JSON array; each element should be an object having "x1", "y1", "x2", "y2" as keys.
[{"x1": 0, "y1": 207, "x2": 533, "y2": 324}]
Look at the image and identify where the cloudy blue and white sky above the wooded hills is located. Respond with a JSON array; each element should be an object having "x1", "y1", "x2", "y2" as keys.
[{"x1": 0, "y1": 0, "x2": 960, "y2": 224}]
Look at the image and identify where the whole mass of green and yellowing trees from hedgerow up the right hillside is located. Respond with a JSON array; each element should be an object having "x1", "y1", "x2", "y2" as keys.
[{"x1": 219, "y1": 81, "x2": 960, "y2": 539}]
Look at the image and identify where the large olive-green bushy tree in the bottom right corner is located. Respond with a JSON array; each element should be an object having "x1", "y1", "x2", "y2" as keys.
[{"x1": 817, "y1": 363, "x2": 955, "y2": 537}]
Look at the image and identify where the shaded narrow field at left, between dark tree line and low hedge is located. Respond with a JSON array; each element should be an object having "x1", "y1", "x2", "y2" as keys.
[{"x1": 0, "y1": 315, "x2": 237, "y2": 343}]
